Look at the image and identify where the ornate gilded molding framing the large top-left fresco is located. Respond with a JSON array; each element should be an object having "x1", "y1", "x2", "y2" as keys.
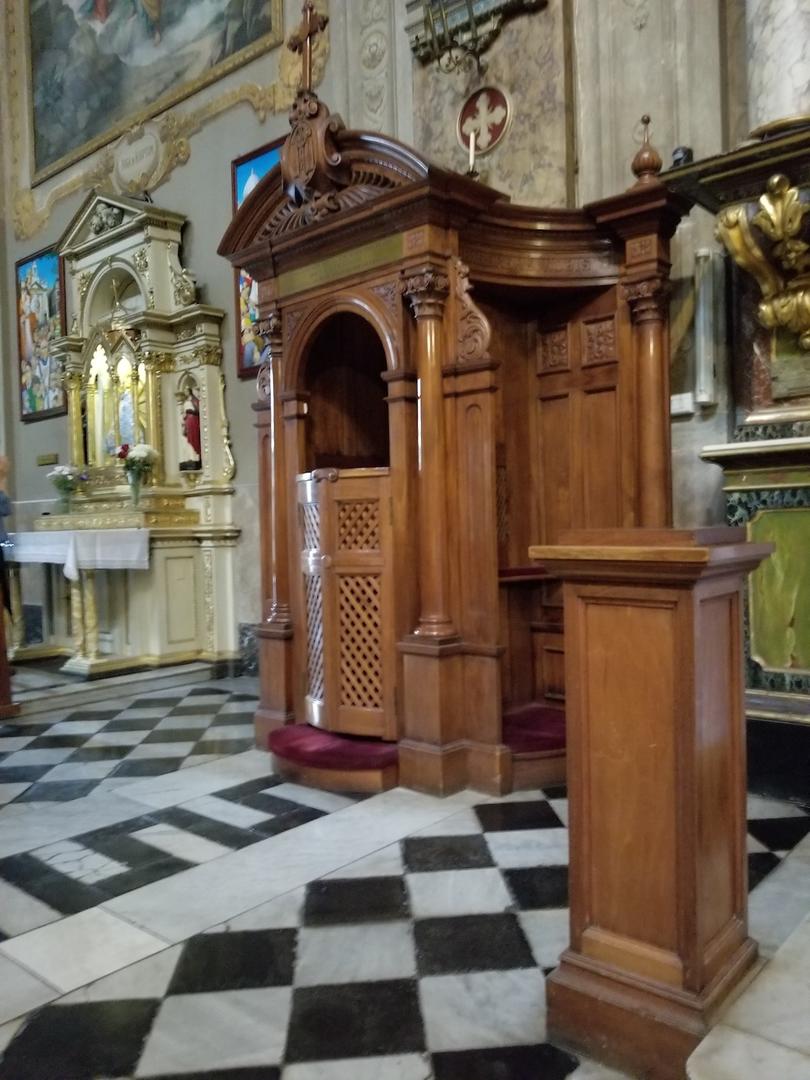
[{"x1": 2, "y1": 0, "x2": 329, "y2": 240}]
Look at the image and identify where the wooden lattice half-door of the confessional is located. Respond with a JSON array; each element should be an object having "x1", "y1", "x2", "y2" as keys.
[{"x1": 298, "y1": 469, "x2": 397, "y2": 739}]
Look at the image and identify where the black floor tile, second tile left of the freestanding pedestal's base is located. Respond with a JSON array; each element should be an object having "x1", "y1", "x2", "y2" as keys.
[{"x1": 285, "y1": 978, "x2": 424, "y2": 1063}]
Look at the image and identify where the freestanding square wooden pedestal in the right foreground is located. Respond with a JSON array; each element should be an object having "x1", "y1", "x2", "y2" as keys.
[{"x1": 530, "y1": 528, "x2": 772, "y2": 1080}]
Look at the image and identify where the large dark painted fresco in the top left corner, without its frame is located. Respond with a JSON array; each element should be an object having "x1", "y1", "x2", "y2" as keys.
[{"x1": 27, "y1": 0, "x2": 281, "y2": 178}]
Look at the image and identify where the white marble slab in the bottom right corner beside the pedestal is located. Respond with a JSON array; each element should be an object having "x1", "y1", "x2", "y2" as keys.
[{"x1": 687, "y1": 1024, "x2": 810, "y2": 1080}]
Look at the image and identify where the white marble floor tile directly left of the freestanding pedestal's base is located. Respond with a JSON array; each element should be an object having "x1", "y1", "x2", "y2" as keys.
[{"x1": 419, "y1": 968, "x2": 545, "y2": 1053}]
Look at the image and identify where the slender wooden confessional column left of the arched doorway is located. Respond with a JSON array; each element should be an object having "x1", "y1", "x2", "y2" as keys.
[{"x1": 253, "y1": 312, "x2": 295, "y2": 750}]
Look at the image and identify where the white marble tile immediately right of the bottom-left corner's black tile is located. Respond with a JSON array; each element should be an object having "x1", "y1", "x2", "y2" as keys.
[{"x1": 135, "y1": 986, "x2": 293, "y2": 1078}]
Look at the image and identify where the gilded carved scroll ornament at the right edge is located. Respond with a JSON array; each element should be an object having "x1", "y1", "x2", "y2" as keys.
[{"x1": 716, "y1": 173, "x2": 810, "y2": 350}]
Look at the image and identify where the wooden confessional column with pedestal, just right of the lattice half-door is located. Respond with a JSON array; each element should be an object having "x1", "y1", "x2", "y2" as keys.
[{"x1": 400, "y1": 265, "x2": 467, "y2": 794}]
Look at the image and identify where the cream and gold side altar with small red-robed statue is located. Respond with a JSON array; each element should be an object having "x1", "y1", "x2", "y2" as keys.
[{"x1": 12, "y1": 193, "x2": 239, "y2": 675}]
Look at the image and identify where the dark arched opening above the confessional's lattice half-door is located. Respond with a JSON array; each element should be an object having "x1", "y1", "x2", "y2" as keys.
[{"x1": 301, "y1": 311, "x2": 390, "y2": 470}]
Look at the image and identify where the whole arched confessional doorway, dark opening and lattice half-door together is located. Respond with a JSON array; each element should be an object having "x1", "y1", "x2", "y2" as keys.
[{"x1": 291, "y1": 310, "x2": 399, "y2": 740}]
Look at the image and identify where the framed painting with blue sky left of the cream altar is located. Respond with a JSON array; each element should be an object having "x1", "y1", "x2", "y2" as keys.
[{"x1": 14, "y1": 247, "x2": 67, "y2": 421}]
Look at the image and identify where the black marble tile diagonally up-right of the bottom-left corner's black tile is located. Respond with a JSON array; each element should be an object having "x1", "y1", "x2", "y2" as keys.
[{"x1": 166, "y1": 930, "x2": 297, "y2": 994}]
